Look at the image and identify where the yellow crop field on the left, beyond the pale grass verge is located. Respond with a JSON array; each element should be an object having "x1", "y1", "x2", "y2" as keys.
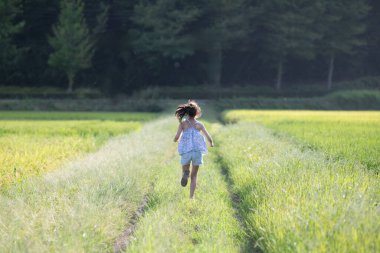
[{"x1": 0, "y1": 112, "x2": 156, "y2": 187}]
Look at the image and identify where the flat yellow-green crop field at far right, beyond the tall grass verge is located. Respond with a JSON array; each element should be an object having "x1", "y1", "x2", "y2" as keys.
[{"x1": 224, "y1": 110, "x2": 380, "y2": 172}]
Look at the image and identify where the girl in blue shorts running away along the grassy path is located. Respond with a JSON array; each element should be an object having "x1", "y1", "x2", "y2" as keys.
[{"x1": 174, "y1": 100, "x2": 214, "y2": 198}]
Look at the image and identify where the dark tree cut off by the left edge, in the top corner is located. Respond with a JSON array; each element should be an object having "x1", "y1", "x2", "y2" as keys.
[{"x1": 0, "y1": 0, "x2": 24, "y2": 81}]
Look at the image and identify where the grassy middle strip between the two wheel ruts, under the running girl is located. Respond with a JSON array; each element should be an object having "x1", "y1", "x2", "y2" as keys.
[{"x1": 127, "y1": 123, "x2": 242, "y2": 252}]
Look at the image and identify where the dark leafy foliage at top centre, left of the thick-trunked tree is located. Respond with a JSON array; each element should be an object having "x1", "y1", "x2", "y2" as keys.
[{"x1": 131, "y1": 0, "x2": 200, "y2": 59}]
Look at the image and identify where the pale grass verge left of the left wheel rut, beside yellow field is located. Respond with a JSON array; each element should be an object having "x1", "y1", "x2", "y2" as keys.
[{"x1": 0, "y1": 118, "x2": 176, "y2": 252}]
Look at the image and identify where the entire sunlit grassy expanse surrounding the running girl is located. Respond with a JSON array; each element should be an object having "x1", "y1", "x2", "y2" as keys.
[{"x1": 0, "y1": 107, "x2": 380, "y2": 253}]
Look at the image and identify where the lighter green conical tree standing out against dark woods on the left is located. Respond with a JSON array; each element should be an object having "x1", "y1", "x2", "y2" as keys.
[{"x1": 49, "y1": 0, "x2": 95, "y2": 92}]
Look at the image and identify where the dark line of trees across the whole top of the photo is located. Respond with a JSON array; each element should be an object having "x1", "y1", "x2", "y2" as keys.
[{"x1": 0, "y1": 0, "x2": 380, "y2": 93}]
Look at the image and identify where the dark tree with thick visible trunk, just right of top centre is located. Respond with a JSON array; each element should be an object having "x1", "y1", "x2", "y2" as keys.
[{"x1": 195, "y1": 0, "x2": 252, "y2": 86}]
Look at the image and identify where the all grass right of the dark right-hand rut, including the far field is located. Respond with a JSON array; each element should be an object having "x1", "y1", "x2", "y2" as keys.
[{"x1": 218, "y1": 111, "x2": 380, "y2": 252}]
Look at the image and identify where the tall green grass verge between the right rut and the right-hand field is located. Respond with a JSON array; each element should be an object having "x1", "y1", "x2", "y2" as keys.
[{"x1": 216, "y1": 122, "x2": 380, "y2": 252}]
